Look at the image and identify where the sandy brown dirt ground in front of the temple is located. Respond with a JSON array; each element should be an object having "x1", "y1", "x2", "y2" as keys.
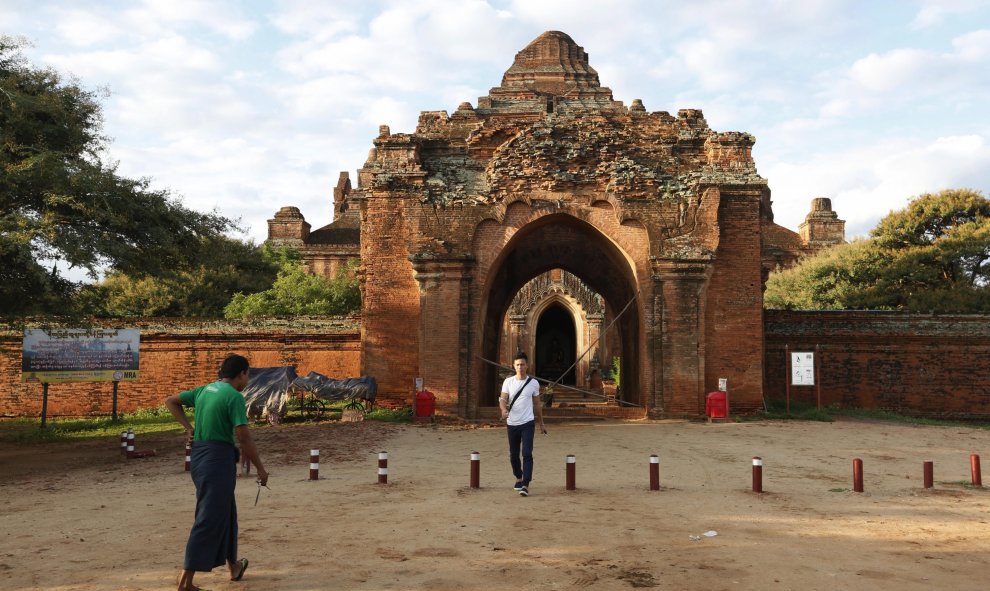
[{"x1": 0, "y1": 421, "x2": 990, "y2": 591}]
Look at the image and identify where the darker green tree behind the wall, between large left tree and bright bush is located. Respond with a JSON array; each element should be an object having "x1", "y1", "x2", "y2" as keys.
[{"x1": 77, "y1": 236, "x2": 284, "y2": 318}]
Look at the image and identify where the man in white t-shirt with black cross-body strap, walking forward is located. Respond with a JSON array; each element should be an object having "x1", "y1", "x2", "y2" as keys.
[{"x1": 498, "y1": 351, "x2": 547, "y2": 497}]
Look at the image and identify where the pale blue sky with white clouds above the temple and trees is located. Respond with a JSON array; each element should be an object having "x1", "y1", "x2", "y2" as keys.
[{"x1": 0, "y1": 0, "x2": 990, "y2": 252}]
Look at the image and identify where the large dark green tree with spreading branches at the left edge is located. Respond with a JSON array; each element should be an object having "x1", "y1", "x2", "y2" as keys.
[{"x1": 0, "y1": 37, "x2": 234, "y2": 315}]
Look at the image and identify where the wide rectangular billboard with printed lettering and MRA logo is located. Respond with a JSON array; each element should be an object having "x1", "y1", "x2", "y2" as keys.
[{"x1": 21, "y1": 328, "x2": 141, "y2": 384}]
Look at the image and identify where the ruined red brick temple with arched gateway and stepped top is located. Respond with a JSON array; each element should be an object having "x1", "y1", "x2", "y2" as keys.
[{"x1": 269, "y1": 31, "x2": 844, "y2": 418}]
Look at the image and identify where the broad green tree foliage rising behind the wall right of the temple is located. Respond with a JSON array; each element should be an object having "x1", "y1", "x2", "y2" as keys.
[{"x1": 764, "y1": 189, "x2": 990, "y2": 313}]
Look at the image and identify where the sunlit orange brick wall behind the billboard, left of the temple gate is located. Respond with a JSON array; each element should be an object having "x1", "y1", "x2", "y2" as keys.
[{"x1": 0, "y1": 318, "x2": 361, "y2": 417}]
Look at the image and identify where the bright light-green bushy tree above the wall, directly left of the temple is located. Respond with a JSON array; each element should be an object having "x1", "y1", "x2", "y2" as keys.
[{"x1": 224, "y1": 258, "x2": 361, "y2": 318}]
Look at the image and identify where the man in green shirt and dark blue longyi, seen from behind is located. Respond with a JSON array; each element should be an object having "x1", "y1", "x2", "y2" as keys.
[{"x1": 165, "y1": 355, "x2": 268, "y2": 591}]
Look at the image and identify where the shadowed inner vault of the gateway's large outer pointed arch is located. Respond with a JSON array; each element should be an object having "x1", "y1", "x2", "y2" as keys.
[{"x1": 468, "y1": 214, "x2": 649, "y2": 415}]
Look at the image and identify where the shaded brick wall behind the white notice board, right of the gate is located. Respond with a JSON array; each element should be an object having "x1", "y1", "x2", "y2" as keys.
[{"x1": 764, "y1": 310, "x2": 990, "y2": 419}]
